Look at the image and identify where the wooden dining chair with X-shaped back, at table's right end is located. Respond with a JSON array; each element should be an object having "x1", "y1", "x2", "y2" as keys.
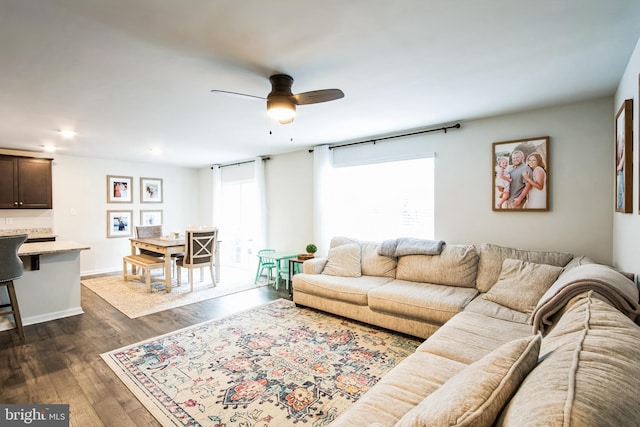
[{"x1": 176, "y1": 227, "x2": 219, "y2": 292}]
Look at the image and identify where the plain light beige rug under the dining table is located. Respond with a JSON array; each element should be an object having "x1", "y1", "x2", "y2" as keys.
[{"x1": 81, "y1": 268, "x2": 265, "y2": 319}]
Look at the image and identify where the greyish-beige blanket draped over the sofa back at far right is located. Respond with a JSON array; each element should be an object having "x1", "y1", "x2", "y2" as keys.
[{"x1": 530, "y1": 264, "x2": 640, "y2": 334}]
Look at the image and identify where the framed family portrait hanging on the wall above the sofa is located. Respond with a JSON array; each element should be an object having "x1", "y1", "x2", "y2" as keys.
[{"x1": 491, "y1": 136, "x2": 550, "y2": 212}]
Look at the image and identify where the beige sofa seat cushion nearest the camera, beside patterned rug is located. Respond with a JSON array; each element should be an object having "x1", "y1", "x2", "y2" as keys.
[{"x1": 331, "y1": 353, "x2": 466, "y2": 427}]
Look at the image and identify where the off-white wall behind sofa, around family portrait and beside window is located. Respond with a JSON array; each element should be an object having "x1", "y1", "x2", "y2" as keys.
[{"x1": 267, "y1": 97, "x2": 613, "y2": 263}]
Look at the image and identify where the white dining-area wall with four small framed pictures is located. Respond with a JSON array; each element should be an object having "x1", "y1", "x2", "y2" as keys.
[{"x1": 0, "y1": 155, "x2": 199, "y2": 275}]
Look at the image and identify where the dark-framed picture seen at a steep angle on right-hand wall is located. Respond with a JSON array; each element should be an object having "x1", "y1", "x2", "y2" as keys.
[{"x1": 613, "y1": 99, "x2": 633, "y2": 213}]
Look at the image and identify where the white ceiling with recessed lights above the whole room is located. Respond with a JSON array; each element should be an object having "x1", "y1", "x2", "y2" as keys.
[{"x1": 0, "y1": 0, "x2": 640, "y2": 167}]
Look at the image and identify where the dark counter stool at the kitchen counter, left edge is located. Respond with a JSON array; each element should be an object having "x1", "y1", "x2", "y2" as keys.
[{"x1": 0, "y1": 234, "x2": 27, "y2": 341}]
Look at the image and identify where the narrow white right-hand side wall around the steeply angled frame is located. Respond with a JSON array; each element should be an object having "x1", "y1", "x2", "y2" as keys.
[{"x1": 611, "y1": 36, "x2": 640, "y2": 273}]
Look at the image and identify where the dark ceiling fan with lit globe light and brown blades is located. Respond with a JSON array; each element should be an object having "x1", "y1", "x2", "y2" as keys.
[{"x1": 211, "y1": 74, "x2": 344, "y2": 125}]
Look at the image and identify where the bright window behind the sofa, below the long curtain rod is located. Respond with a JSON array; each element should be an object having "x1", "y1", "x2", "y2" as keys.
[{"x1": 327, "y1": 157, "x2": 434, "y2": 241}]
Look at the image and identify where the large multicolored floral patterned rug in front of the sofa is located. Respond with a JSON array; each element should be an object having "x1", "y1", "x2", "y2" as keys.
[{"x1": 101, "y1": 300, "x2": 421, "y2": 427}]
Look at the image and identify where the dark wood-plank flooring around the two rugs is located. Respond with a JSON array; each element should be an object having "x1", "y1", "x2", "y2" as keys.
[{"x1": 0, "y1": 276, "x2": 289, "y2": 427}]
